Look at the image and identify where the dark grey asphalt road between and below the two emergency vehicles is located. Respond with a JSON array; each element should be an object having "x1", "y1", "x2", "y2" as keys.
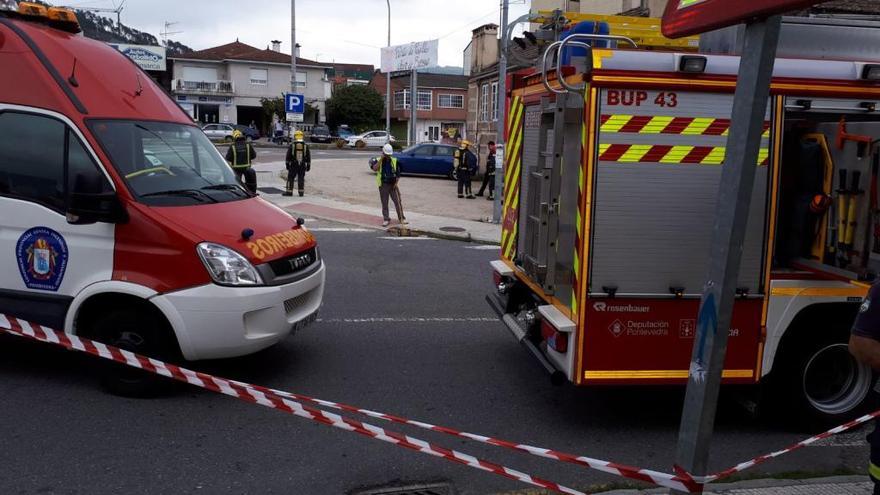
[{"x1": 0, "y1": 222, "x2": 867, "y2": 494}]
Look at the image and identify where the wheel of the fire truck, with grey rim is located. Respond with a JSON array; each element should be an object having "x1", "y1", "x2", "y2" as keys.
[{"x1": 772, "y1": 332, "x2": 874, "y2": 428}]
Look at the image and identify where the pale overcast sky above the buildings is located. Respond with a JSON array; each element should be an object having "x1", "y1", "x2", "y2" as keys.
[{"x1": 63, "y1": 0, "x2": 529, "y2": 66}]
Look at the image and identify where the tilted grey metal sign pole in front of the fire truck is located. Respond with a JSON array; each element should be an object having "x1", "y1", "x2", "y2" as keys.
[{"x1": 674, "y1": 16, "x2": 781, "y2": 493}]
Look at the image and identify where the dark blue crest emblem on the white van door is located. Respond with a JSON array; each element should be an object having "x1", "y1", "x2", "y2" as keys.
[{"x1": 15, "y1": 227, "x2": 68, "y2": 292}]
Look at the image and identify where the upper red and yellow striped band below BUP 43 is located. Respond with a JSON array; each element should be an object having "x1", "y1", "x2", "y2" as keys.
[{"x1": 600, "y1": 114, "x2": 770, "y2": 137}]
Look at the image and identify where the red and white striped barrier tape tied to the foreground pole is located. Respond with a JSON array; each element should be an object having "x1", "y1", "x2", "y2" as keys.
[{"x1": 0, "y1": 313, "x2": 880, "y2": 495}]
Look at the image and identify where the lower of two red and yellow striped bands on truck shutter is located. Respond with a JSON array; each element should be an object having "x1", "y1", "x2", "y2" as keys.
[{"x1": 599, "y1": 143, "x2": 770, "y2": 166}]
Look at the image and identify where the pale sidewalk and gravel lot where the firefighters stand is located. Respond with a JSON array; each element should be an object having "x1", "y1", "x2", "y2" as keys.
[{"x1": 254, "y1": 158, "x2": 501, "y2": 244}]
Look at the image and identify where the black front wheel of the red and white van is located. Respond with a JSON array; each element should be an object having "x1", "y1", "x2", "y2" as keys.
[{"x1": 89, "y1": 307, "x2": 176, "y2": 397}]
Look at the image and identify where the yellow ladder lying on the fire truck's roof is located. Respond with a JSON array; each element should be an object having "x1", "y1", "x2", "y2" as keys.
[{"x1": 538, "y1": 10, "x2": 700, "y2": 51}]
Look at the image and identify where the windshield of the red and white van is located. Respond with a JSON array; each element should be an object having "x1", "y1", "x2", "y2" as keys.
[{"x1": 89, "y1": 120, "x2": 251, "y2": 206}]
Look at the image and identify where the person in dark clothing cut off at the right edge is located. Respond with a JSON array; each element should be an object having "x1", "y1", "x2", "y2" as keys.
[{"x1": 849, "y1": 283, "x2": 880, "y2": 495}]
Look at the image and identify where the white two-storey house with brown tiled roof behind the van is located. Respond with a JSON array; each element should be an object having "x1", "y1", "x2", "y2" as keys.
[{"x1": 170, "y1": 40, "x2": 332, "y2": 130}]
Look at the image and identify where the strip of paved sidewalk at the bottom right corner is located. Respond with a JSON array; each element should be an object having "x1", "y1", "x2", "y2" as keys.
[{"x1": 600, "y1": 476, "x2": 874, "y2": 495}]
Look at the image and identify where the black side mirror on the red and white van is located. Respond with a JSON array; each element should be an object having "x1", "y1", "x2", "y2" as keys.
[{"x1": 67, "y1": 174, "x2": 128, "y2": 225}]
